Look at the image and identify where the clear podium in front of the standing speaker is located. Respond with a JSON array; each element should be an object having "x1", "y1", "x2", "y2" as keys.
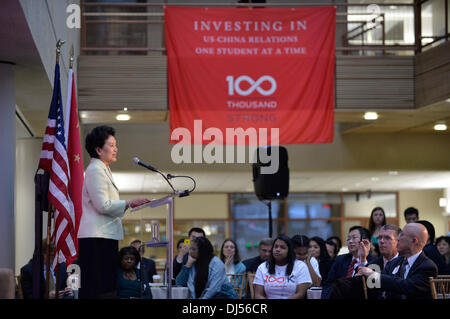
[{"x1": 131, "y1": 193, "x2": 179, "y2": 299}]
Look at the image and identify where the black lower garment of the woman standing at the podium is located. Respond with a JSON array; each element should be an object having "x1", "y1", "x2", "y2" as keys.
[{"x1": 78, "y1": 238, "x2": 119, "y2": 299}]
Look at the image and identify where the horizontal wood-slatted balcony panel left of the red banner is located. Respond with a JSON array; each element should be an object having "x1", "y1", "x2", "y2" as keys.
[{"x1": 78, "y1": 56, "x2": 167, "y2": 110}]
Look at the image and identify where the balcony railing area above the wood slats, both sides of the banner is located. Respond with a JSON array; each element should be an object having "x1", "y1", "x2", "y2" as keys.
[{"x1": 81, "y1": 0, "x2": 450, "y2": 55}]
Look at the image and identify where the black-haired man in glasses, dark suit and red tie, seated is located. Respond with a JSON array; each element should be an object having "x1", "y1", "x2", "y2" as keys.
[{"x1": 322, "y1": 226, "x2": 375, "y2": 299}]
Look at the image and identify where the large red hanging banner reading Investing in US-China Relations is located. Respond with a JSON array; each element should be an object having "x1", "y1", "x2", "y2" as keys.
[{"x1": 165, "y1": 6, "x2": 336, "y2": 145}]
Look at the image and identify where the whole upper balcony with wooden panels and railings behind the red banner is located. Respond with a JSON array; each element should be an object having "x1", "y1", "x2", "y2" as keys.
[{"x1": 79, "y1": 0, "x2": 450, "y2": 133}]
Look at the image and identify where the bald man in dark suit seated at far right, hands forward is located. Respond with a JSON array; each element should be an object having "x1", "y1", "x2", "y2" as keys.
[{"x1": 358, "y1": 223, "x2": 437, "y2": 299}]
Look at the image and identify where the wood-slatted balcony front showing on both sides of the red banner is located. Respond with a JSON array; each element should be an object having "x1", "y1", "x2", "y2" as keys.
[{"x1": 79, "y1": 56, "x2": 414, "y2": 110}]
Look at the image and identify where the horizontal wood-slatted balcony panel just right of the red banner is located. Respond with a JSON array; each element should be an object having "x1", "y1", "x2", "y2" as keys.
[{"x1": 336, "y1": 56, "x2": 414, "y2": 109}]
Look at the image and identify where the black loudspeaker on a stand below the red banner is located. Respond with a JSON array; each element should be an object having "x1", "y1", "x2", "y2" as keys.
[{"x1": 253, "y1": 146, "x2": 289, "y2": 200}]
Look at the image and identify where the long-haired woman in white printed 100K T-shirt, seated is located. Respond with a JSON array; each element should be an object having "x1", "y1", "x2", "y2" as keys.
[{"x1": 253, "y1": 236, "x2": 312, "y2": 299}]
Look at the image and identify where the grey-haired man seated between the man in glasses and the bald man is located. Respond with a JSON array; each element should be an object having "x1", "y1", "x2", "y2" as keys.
[{"x1": 373, "y1": 224, "x2": 402, "y2": 270}]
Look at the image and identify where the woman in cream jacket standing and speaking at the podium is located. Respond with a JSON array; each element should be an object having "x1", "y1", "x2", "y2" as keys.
[{"x1": 78, "y1": 126, "x2": 149, "y2": 299}]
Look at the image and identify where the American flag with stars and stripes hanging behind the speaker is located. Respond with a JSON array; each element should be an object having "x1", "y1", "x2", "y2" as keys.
[{"x1": 39, "y1": 64, "x2": 77, "y2": 269}]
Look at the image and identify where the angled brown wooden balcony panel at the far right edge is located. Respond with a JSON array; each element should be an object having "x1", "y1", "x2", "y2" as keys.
[{"x1": 416, "y1": 43, "x2": 450, "y2": 107}]
